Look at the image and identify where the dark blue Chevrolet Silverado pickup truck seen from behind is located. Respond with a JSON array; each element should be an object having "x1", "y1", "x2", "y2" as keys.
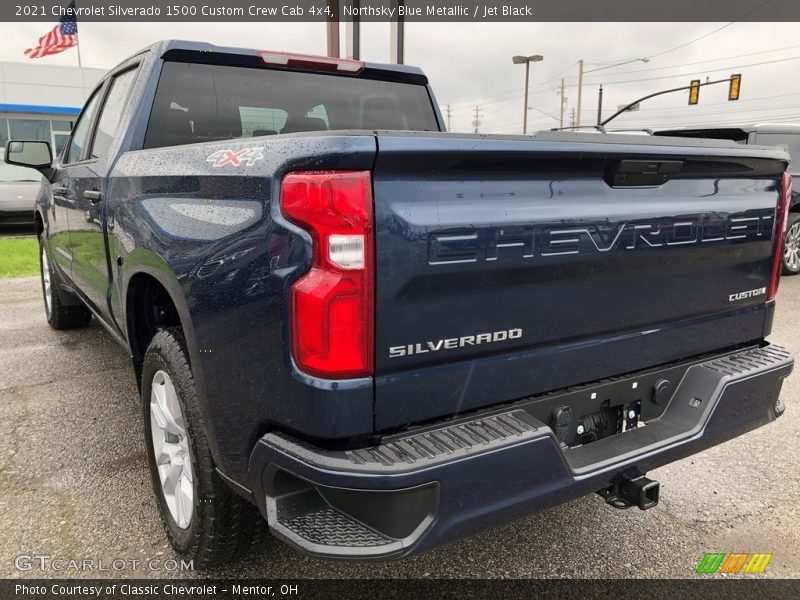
[{"x1": 5, "y1": 41, "x2": 793, "y2": 567}]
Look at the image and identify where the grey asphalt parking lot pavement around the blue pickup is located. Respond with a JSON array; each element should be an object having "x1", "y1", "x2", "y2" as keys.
[{"x1": 0, "y1": 277, "x2": 800, "y2": 578}]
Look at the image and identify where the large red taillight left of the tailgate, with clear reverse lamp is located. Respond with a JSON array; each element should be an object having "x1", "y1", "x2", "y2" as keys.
[{"x1": 281, "y1": 171, "x2": 374, "y2": 378}]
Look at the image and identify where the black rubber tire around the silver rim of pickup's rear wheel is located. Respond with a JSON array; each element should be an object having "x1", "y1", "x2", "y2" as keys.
[{"x1": 142, "y1": 329, "x2": 267, "y2": 569}]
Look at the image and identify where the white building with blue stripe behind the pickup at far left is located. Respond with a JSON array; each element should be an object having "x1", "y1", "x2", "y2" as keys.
[{"x1": 0, "y1": 62, "x2": 105, "y2": 154}]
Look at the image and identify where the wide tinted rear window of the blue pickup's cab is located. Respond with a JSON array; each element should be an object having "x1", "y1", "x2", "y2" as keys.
[{"x1": 144, "y1": 61, "x2": 439, "y2": 148}]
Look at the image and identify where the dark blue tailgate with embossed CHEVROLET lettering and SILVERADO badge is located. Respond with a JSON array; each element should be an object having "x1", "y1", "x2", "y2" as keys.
[{"x1": 374, "y1": 132, "x2": 786, "y2": 430}]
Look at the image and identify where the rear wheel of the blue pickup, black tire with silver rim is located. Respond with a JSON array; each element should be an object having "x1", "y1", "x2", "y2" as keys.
[{"x1": 142, "y1": 329, "x2": 266, "y2": 569}]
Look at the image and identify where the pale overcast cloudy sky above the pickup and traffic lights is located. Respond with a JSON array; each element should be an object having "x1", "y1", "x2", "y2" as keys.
[{"x1": 0, "y1": 23, "x2": 800, "y2": 133}]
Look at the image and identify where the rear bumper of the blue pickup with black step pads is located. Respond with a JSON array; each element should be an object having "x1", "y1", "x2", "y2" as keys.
[{"x1": 250, "y1": 345, "x2": 794, "y2": 559}]
